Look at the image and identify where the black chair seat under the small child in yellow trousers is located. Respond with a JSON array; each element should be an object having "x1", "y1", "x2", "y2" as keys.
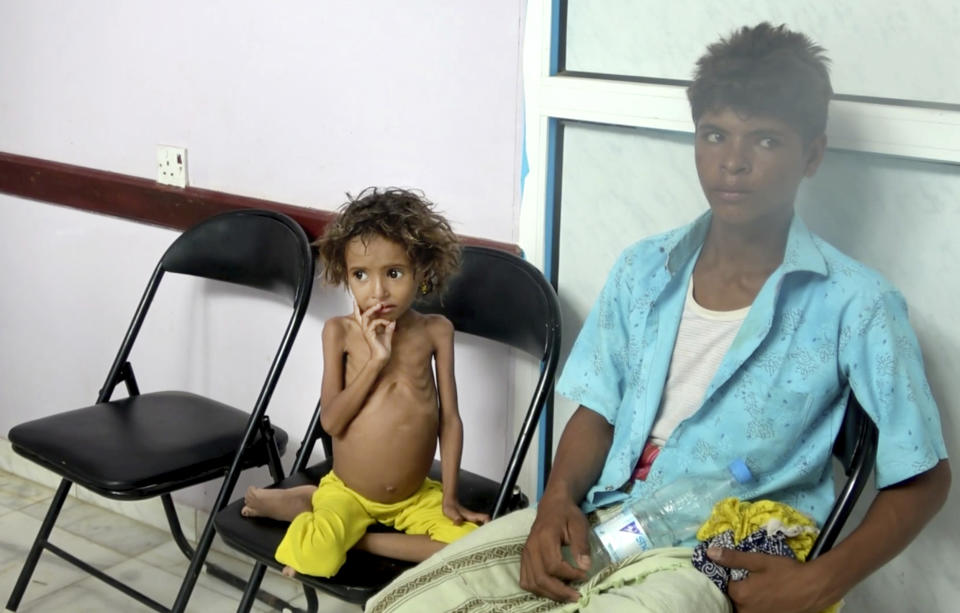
[{"x1": 215, "y1": 460, "x2": 520, "y2": 604}]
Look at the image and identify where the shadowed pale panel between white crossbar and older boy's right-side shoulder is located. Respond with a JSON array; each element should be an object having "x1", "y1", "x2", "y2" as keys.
[{"x1": 798, "y1": 146, "x2": 960, "y2": 450}]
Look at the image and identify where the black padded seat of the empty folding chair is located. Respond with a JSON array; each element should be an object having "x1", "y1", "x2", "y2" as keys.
[{"x1": 9, "y1": 391, "x2": 287, "y2": 499}]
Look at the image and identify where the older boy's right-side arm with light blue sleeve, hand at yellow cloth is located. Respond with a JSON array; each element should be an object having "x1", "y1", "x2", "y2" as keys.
[{"x1": 714, "y1": 290, "x2": 950, "y2": 613}]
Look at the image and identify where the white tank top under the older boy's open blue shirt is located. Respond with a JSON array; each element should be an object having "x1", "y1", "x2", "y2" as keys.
[{"x1": 650, "y1": 279, "x2": 750, "y2": 447}]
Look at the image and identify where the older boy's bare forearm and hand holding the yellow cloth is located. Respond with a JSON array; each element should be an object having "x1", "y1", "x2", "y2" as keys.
[{"x1": 710, "y1": 460, "x2": 950, "y2": 613}]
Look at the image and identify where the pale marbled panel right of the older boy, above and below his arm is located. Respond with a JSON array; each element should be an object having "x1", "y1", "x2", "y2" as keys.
[{"x1": 798, "y1": 150, "x2": 960, "y2": 611}]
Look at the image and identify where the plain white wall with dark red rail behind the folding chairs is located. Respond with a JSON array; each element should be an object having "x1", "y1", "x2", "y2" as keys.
[{"x1": 0, "y1": 0, "x2": 521, "y2": 506}]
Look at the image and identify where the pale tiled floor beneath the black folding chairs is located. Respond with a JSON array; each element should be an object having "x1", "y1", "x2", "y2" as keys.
[{"x1": 0, "y1": 471, "x2": 360, "y2": 613}]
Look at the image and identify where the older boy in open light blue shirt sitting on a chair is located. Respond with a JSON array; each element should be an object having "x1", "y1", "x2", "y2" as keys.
[{"x1": 367, "y1": 23, "x2": 950, "y2": 613}]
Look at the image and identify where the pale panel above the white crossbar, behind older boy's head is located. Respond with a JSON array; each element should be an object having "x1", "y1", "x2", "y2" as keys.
[{"x1": 566, "y1": 0, "x2": 960, "y2": 103}]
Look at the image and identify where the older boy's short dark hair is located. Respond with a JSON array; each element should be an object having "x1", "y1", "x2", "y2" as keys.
[{"x1": 687, "y1": 22, "x2": 833, "y2": 144}]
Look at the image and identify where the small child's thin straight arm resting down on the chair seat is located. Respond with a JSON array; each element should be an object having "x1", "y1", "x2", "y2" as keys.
[{"x1": 427, "y1": 317, "x2": 489, "y2": 524}]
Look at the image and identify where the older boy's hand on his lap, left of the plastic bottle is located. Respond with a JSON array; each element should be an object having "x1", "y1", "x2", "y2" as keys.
[{"x1": 520, "y1": 497, "x2": 590, "y2": 602}]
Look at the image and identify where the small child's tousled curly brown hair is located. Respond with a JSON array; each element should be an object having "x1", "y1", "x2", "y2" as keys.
[{"x1": 315, "y1": 187, "x2": 460, "y2": 294}]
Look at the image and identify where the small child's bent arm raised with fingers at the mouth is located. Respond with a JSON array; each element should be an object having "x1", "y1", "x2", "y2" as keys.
[{"x1": 320, "y1": 307, "x2": 393, "y2": 437}]
